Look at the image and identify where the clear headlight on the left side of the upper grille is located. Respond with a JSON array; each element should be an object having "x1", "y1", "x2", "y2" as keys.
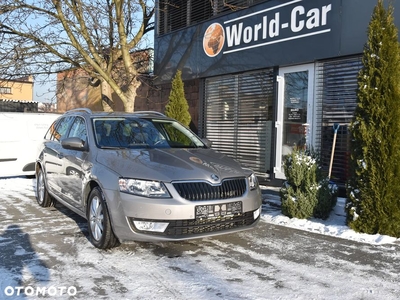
[{"x1": 119, "y1": 178, "x2": 171, "y2": 198}]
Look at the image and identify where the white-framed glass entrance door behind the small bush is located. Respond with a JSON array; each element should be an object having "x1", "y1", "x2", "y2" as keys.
[{"x1": 274, "y1": 64, "x2": 314, "y2": 179}]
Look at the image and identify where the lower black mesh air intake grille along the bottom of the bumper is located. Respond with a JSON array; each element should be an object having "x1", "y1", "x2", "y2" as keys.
[{"x1": 130, "y1": 211, "x2": 256, "y2": 238}]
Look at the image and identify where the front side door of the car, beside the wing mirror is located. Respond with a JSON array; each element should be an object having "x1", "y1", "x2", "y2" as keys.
[{"x1": 60, "y1": 116, "x2": 88, "y2": 210}]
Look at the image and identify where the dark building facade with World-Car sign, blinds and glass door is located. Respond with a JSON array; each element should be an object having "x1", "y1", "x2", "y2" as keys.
[{"x1": 154, "y1": 0, "x2": 400, "y2": 184}]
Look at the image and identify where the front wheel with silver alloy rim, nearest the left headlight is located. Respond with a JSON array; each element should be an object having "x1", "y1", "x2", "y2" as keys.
[{"x1": 87, "y1": 187, "x2": 119, "y2": 250}]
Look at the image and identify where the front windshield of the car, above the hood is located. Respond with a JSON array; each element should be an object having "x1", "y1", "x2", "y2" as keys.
[{"x1": 93, "y1": 117, "x2": 206, "y2": 148}]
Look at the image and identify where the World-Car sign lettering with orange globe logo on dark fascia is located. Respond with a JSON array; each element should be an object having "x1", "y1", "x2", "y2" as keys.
[{"x1": 203, "y1": 0, "x2": 332, "y2": 57}]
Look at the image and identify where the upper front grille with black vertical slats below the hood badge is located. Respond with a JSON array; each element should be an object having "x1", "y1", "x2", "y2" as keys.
[{"x1": 173, "y1": 178, "x2": 246, "y2": 201}]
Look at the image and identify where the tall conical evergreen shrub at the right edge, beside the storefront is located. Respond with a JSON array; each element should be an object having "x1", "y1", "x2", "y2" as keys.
[{"x1": 346, "y1": 0, "x2": 400, "y2": 237}]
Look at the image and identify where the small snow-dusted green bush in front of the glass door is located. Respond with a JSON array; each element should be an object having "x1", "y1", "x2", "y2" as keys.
[{"x1": 280, "y1": 149, "x2": 337, "y2": 219}]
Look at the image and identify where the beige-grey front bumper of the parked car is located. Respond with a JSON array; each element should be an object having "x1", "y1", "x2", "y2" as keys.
[{"x1": 104, "y1": 183, "x2": 261, "y2": 241}]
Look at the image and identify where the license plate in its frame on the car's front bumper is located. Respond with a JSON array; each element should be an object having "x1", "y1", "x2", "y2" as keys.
[{"x1": 195, "y1": 201, "x2": 243, "y2": 219}]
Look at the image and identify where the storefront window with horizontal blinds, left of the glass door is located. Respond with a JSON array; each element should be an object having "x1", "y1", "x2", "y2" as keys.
[{"x1": 204, "y1": 70, "x2": 274, "y2": 174}]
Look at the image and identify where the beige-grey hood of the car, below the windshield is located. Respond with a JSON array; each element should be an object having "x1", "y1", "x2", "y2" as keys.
[{"x1": 97, "y1": 148, "x2": 250, "y2": 182}]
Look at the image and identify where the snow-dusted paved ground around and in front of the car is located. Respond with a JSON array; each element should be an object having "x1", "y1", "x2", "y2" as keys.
[{"x1": 0, "y1": 177, "x2": 400, "y2": 300}]
